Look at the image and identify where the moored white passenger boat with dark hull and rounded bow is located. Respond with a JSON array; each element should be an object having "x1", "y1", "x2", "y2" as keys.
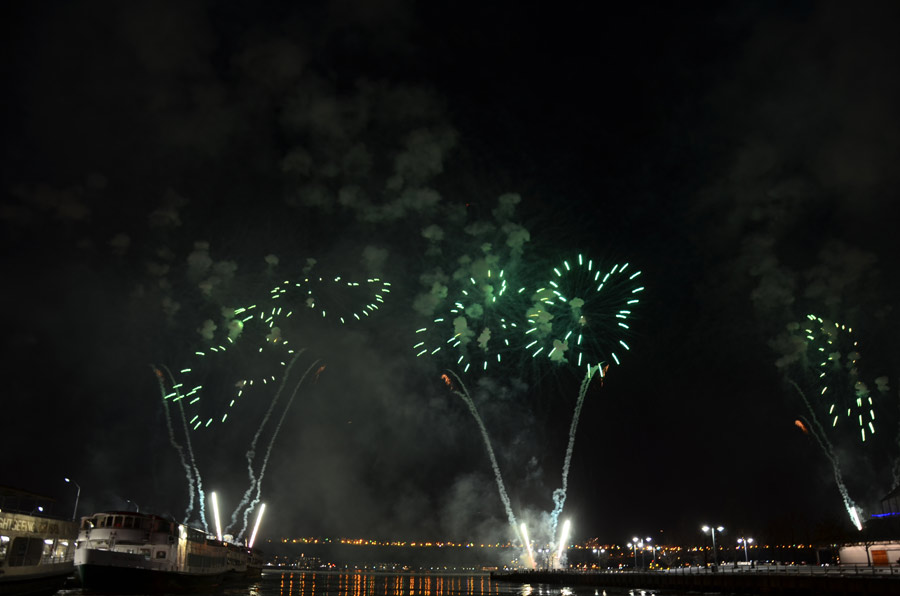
[{"x1": 75, "y1": 511, "x2": 234, "y2": 593}]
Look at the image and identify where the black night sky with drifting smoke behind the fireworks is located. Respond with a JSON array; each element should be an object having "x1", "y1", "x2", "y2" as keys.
[{"x1": 0, "y1": 0, "x2": 900, "y2": 556}]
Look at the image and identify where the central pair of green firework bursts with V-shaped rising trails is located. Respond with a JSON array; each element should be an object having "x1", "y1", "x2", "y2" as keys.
[{"x1": 413, "y1": 255, "x2": 644, "y2": 557}]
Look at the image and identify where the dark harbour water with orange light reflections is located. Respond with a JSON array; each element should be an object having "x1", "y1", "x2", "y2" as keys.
[{"x1": 57, "y1": 570, "x2": 724, "y2": 596}]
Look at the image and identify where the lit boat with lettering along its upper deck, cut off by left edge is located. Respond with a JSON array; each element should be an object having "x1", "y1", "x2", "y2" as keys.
[{"x1": 0, "y1": 487, "x2": 78, "y2": 596}]
